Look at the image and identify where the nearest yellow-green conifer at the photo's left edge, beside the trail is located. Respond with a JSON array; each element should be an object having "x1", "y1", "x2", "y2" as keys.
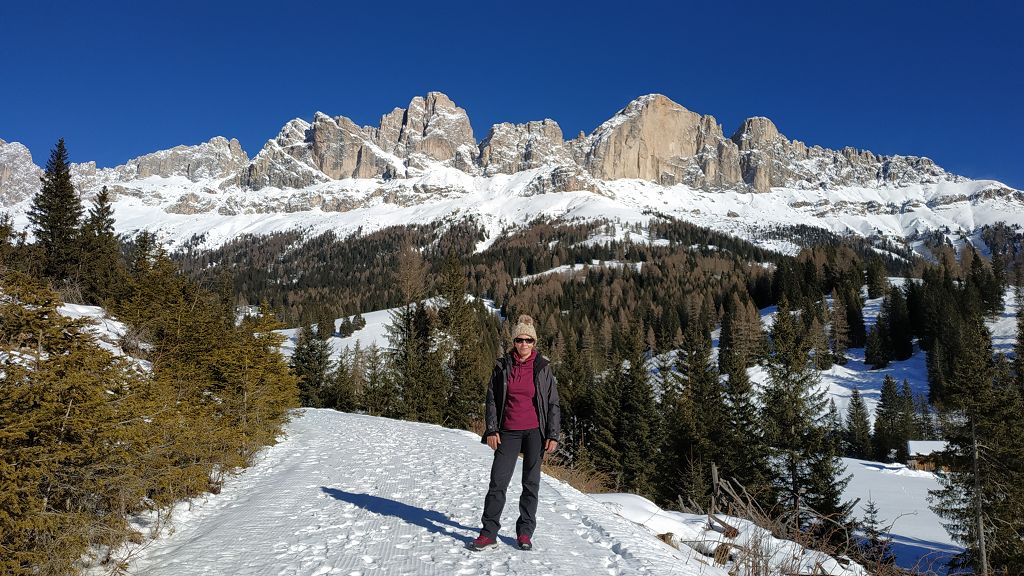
[{"x1": 0, "y1": 272, "x2": 153, "y2": 575}]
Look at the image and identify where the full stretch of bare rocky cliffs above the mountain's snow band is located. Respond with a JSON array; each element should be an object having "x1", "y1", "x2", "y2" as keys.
[{"x1": 0, "y1": 88, "x2": 963, "y2": 210}]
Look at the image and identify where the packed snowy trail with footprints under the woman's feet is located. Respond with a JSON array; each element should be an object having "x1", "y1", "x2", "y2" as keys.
[{"x1": 123, "y1": 410, "x2": 724, "y2": 576}]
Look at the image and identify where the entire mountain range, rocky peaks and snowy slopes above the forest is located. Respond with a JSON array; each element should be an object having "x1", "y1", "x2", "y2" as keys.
[{"x1": 0, "y1": 92, "x2": 1024, "y2": 252}]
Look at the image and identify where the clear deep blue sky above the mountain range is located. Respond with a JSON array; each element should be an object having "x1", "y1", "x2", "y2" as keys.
[{"x1": 0, "y1": 0, "x2": 1024, "y2": 189}]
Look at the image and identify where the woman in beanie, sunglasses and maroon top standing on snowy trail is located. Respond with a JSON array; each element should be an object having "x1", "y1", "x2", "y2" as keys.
[{"x1": 469, "y1": 315, "x2": 561, "y2": 550}]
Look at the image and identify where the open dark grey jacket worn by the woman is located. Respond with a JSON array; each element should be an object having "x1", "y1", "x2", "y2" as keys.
[{"x1": 480, "y1": 355, "x2": 562, "y2": 443}]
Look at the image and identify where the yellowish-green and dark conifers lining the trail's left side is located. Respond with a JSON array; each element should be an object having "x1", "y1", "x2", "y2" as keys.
[{"x1": 0, "y1": 140, "x2": 297, "y2": 575}]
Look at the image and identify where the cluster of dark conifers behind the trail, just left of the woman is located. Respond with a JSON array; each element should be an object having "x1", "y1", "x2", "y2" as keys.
[{"x1": 292, "y1": 252, "x2": 510, "y2": 428}]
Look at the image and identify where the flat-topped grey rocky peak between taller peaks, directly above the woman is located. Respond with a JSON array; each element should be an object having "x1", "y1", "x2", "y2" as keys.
[{"x1": 477, "y1": 119, "x2": 575, "y2": 175}]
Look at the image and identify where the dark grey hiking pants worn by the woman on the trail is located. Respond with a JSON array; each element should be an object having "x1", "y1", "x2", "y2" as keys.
[{"x1": 480, "y1": 428, "x2": 544, "y2": 539}]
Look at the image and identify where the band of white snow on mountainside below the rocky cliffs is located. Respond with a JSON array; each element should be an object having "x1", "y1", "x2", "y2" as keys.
[{"x1": 0, "y1": 151, "x2": 1024, "y2": 253}]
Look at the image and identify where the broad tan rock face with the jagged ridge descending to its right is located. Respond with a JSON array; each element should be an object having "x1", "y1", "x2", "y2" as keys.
[{"x1": 574, "y1": 94, "x2": 957, "y2": 192}]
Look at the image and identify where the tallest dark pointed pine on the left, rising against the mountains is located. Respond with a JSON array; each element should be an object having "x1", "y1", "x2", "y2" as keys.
[{"x1": 28, "y1": 138, "x2": 83, "y2": 284}]
